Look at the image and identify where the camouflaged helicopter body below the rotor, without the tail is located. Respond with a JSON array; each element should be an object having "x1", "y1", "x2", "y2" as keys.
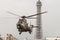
[{"x1": 17, "y1": 19, "x2": 32, "y2": 34}]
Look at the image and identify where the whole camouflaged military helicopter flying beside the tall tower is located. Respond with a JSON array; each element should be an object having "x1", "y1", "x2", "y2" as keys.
[{"x1": 8, "y1": 11, "x2": 47, "y2": 34}]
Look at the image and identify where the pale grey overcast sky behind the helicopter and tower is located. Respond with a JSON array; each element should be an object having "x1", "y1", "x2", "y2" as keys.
[{"x1": 0, "y1": 0, "x2": 60, "y2": 39}]
